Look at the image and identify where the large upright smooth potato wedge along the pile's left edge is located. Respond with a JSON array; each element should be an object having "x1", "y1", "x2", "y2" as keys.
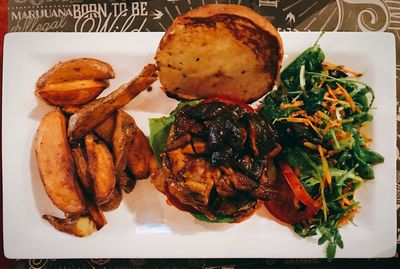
[{"x1": 35, "y1": 110, "x2": 86, "y2": 214}]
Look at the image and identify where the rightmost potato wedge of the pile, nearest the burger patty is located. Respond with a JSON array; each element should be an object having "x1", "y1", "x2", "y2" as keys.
[{"x1": 128, "y1": 128, "x2": 153, "y2": 179}]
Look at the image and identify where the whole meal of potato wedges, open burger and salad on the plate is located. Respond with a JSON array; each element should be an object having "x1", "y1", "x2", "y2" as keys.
[{"x1": 26, "y1": 5, "x2": 390, "y2": 259}]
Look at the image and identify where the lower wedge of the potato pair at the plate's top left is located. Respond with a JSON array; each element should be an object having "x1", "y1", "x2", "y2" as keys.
[{"x1": 36, "y1": 79, "x2": 108, "y2": 106}]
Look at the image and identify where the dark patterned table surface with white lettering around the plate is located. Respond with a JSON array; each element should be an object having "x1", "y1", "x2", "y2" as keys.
[{"x1": 8, "y1": 0, "x2": 400, "y2": 268}]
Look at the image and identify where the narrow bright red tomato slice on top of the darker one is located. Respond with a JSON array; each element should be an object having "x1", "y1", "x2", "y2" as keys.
[{"x1": 279, "y1": 161, "x2": 316, "y2": 206}]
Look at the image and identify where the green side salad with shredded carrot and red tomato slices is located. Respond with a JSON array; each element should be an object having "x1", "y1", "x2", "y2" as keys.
[{"x1": 259, "y1": 35, "x2": 384, "y2": 260}]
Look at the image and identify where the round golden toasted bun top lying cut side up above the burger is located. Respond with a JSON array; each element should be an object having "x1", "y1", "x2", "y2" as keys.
[{"x1": 155, "y1": 4, "x2": 283, "y2": 103}]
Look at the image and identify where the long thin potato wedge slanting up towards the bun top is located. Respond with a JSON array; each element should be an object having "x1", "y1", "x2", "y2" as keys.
[{"x1": 68, "y1": 64, "x2": 157, "y2": 138}]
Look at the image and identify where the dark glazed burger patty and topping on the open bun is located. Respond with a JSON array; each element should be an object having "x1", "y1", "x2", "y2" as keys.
[{"x1": 162, "y1": 101, "x2": 278, "y2": 219}]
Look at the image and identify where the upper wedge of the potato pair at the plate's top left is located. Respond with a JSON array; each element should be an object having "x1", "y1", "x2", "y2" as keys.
[{"x1": 36, "y1": 58, "x2": 115, "y2": 85}]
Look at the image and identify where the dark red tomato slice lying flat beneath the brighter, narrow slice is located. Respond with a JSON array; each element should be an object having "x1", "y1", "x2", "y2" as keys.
[{"x1": 264, "y1": 168, "x2": 321, "y2": 224}]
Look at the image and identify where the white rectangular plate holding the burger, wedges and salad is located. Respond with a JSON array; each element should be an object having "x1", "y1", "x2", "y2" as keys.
[{"x1": 2, "y1": 33, "x2": 396, "y2": 258}]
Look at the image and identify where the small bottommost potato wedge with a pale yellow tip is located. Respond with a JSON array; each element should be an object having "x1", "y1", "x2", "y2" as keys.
[{"x1": 43, "y1": 215, "x2": 96, "y2": 237}]
